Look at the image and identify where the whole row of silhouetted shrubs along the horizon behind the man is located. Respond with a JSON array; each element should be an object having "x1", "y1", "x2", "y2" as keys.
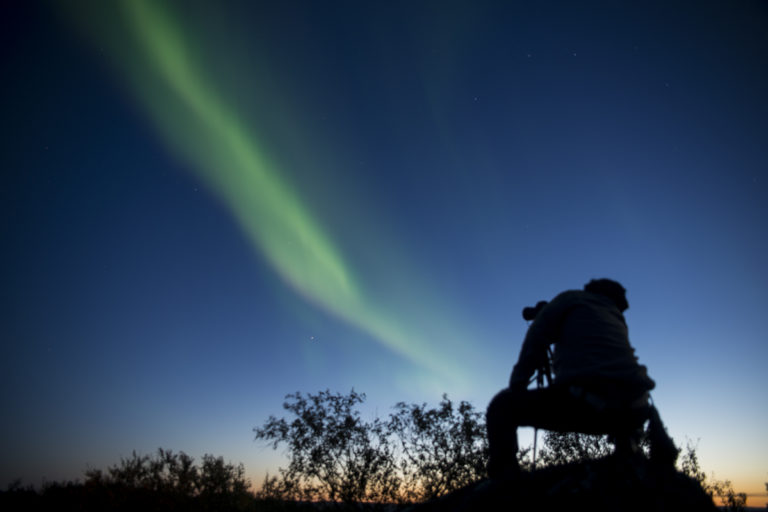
[{"x1": 0, "y1": 390, "x2": 746, "y2": 511}]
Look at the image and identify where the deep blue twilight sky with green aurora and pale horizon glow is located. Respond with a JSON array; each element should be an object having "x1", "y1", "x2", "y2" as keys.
[{"x1": 0, "y1": 0, "x2": 768, "y2": 505}]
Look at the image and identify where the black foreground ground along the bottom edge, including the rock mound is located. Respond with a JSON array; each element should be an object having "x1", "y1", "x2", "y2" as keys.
[{"x1": 0, "y1": 457, "x2": 718, "y2": 512}]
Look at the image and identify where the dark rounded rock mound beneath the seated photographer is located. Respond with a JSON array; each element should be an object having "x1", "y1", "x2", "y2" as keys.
[{"x1": 408, "y1": 457, "x2": 717, "y2": 512}]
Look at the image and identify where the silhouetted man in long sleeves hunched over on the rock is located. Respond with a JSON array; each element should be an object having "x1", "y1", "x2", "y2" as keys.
[{"x1": 487, "y1": 279, "x2": 664, "y2": 478}]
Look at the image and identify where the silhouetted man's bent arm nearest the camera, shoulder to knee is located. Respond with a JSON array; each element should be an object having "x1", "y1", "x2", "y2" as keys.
[{"x1": 509, "y1": 292, "x2": 570, "y2": 389}]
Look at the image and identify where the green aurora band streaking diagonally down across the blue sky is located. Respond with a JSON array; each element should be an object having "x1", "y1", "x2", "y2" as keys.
[{"x1": 69, "y1": 0, "x2": 467, "y2": 385}]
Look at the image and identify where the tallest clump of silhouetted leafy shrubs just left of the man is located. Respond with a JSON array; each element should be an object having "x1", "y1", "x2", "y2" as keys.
[{"x1": 254, "y1": 390, "x2": 529, "y2": 503}]
